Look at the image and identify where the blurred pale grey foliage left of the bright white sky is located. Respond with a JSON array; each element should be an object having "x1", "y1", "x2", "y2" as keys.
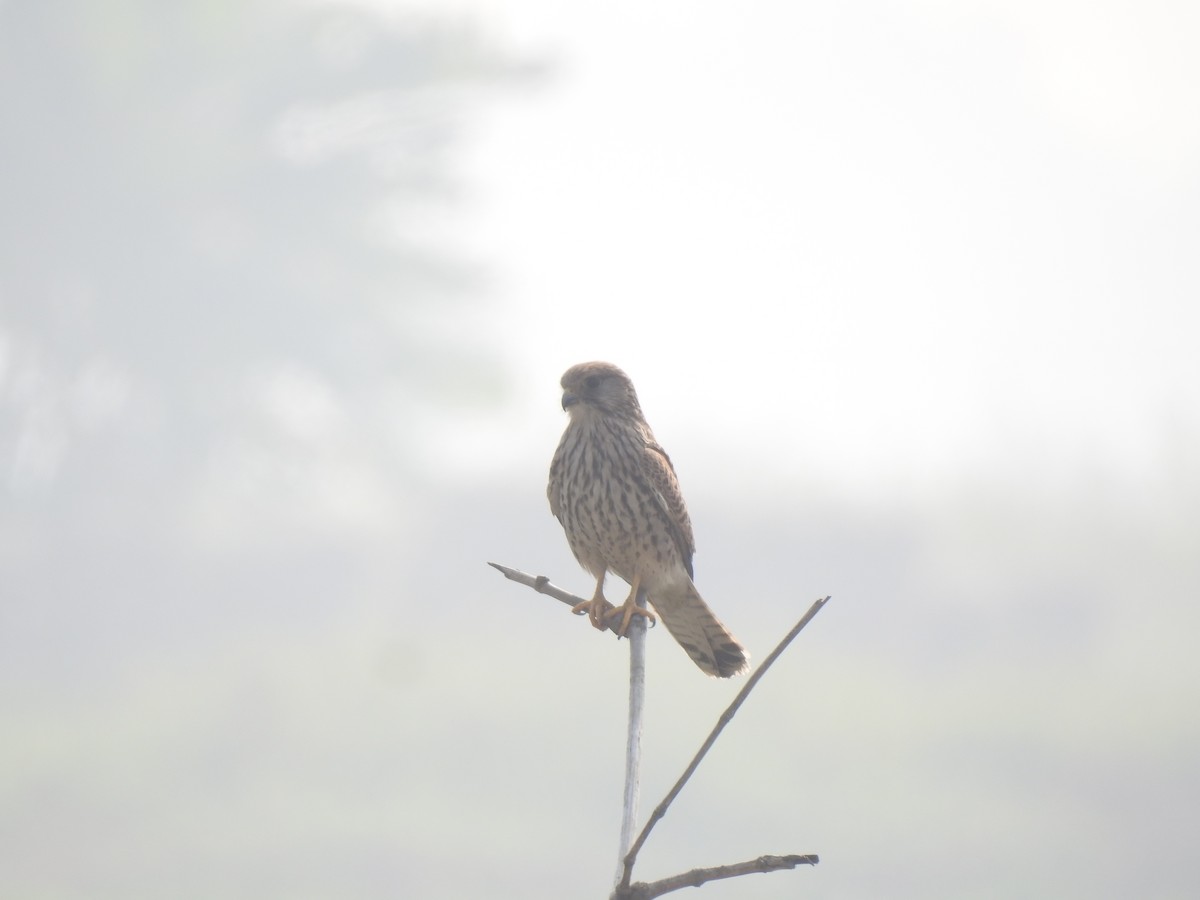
[{"x1": 0, "y1": 0, "x2": 540, "y2": 508}]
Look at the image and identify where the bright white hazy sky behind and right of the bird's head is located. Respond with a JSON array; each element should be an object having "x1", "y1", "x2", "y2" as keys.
[{"x1": 384, "y1": 2, "x2": 1200, "y2": 501}]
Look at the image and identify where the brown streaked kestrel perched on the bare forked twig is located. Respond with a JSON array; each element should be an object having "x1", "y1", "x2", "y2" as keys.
[{"x1": 546, "y1": 361, "x2": 750, "y2": 678}]
